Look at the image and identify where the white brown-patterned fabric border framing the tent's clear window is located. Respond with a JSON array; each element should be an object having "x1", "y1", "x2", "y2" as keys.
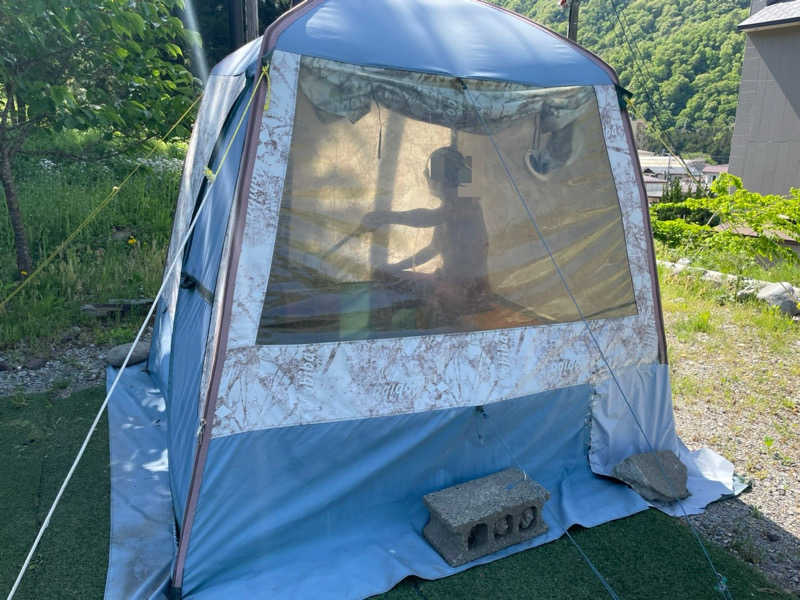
[{"x1": 208, "y1": 51, "x2": 660, "y2": 437}]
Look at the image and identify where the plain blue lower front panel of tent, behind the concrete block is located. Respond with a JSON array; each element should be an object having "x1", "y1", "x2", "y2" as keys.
[{"x1": 183, "y1": 385, "x2": 647, "y2": 599}]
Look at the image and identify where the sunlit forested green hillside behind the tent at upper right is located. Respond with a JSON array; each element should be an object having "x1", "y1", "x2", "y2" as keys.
[{"x1": 493, "y1": 0, "x2": 749, "y2": 162}]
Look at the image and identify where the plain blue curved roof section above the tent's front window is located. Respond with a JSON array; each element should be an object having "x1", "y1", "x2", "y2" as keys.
[{"x1": 275, "y1": 0, "x2": 616, "y2": 87}]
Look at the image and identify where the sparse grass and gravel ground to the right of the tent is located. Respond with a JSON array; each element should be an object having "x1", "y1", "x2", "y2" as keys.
[{"x1": 663, "y1": 286, "x2": 800, "y2": 594}]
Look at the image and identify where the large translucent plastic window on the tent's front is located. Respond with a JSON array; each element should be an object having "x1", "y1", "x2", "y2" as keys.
[{"x1": 257, "y1": 57, "x2": 636, "y2": 344}]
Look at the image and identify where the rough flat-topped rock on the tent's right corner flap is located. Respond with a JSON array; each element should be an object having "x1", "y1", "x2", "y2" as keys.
[{"x1": 612, "y1": 450, "x2": 689, "y2": 503}]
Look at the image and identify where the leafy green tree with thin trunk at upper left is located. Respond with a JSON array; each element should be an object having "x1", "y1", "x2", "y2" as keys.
[{"x1": 0, "y1": 0, "x2": 195, "y2": 277}]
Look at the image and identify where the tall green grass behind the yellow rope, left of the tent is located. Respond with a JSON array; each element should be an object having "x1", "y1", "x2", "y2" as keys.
[{"x1": 0, "y1": 154, "x2": 180, "y2": 348}]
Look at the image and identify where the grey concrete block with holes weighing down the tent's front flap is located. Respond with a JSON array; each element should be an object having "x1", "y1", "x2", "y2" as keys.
[{"x1": 423, "y1": 469, "x2": 550, "y2": 567}]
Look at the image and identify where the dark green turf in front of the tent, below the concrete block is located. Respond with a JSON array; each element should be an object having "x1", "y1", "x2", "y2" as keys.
[{"x1": 376, "y1": 510, "x2": 792, "y2": 600}]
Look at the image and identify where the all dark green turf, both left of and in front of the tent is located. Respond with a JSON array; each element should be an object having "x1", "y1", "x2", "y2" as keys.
[{"x1": 0, "y1": 388, "x2": 790, "y2": 600}]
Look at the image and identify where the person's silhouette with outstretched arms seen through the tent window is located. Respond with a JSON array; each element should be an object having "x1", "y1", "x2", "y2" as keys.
[{"x1": 361, "y1": 146, "x2": 490, "y2": 326}]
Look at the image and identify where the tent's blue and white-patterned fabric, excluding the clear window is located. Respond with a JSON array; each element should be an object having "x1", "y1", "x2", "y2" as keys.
[{"x1": 112, "y1": 0, "x2": 744, "y2": 598}]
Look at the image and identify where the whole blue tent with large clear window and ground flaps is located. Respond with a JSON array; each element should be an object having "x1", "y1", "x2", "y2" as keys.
[{"x1": 106, "y1": 0, "x2": 733, "y2": 599}]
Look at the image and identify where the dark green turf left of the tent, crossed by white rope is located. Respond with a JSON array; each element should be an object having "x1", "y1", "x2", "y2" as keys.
[{"x1": 0, "y1": 388, "x2": 109, "y2": 600}]
